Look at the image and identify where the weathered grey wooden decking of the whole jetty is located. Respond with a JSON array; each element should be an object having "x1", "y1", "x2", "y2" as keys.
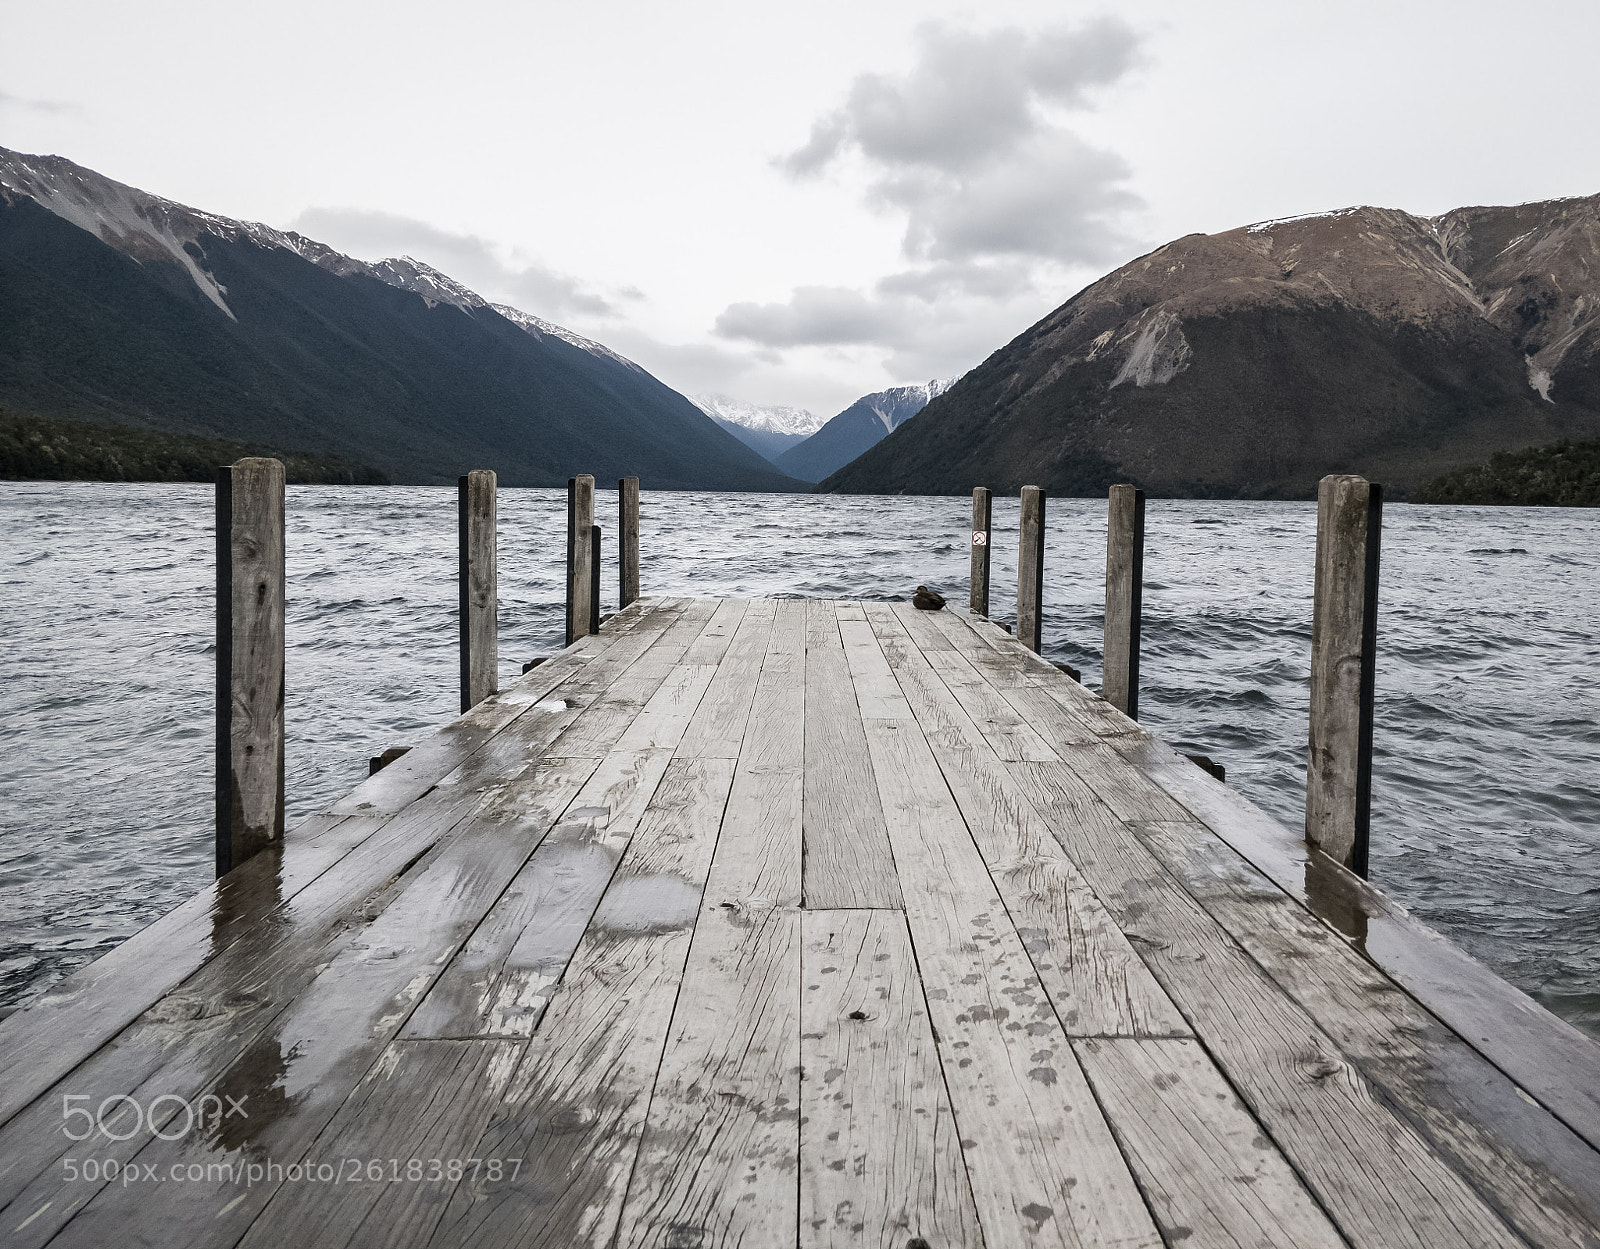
[{"x1": 0, "y1": 600, "x2": 1600, "y2": 1249}]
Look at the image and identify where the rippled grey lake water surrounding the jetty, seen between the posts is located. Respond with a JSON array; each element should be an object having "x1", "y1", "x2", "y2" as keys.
[{"x1": 0, "y1": 483, "x2": 1600, "y2": 1035}]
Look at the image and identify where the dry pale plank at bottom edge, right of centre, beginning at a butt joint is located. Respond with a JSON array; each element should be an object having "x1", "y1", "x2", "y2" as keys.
[{"x1": 1074, "y1": 1038, "x2": 1346, "y2": 1249}]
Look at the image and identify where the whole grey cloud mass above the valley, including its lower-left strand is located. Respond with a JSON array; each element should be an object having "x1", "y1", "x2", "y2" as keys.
[{"x1": 715, "y1": 18, "x2": 1141, "y2": 363}]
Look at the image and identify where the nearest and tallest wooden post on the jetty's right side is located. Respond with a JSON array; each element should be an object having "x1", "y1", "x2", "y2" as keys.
[{"x1": 1306, "y1": 475, "x2": 1384, "y2": 876}]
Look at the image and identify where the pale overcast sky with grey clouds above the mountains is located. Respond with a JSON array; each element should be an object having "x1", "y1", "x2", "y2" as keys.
[{"x1": 0, "y1": 0, "x2": 1600, "y2": 416}]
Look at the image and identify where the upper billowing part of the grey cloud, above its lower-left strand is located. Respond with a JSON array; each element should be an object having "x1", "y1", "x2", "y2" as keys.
[{"x1": 779, "y1": 18, "x2": 1139, "y2": 264}]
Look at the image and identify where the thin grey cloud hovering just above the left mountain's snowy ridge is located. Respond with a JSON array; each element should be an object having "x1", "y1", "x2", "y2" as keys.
[{"x1": 293, "y1": 208, "x2": 617, "y2": 321}]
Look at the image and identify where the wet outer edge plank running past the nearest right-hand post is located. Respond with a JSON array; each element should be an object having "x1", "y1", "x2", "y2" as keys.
[{"x1": 1130, "y1": 742, "x2": 1600, "y2": 1148}]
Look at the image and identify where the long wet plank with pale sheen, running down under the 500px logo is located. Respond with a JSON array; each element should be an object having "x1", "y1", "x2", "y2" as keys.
[{"x1": 37, "y1": 760, "x2": 594, "y2": 1246}]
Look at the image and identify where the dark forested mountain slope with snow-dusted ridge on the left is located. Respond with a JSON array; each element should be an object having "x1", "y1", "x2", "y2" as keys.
[{"x1": 0, "y1": 149, "x2": 803, "y2": 489}]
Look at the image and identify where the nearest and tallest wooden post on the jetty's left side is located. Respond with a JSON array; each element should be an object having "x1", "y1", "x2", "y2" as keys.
[{"x1": 216, "y1": 457, "x2": 283, "y2": 876}]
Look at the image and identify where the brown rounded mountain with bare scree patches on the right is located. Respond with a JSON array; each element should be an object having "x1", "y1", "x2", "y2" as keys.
[{"x1": 819, "y1": 195, "x2": 1600, "y2": 497}]
